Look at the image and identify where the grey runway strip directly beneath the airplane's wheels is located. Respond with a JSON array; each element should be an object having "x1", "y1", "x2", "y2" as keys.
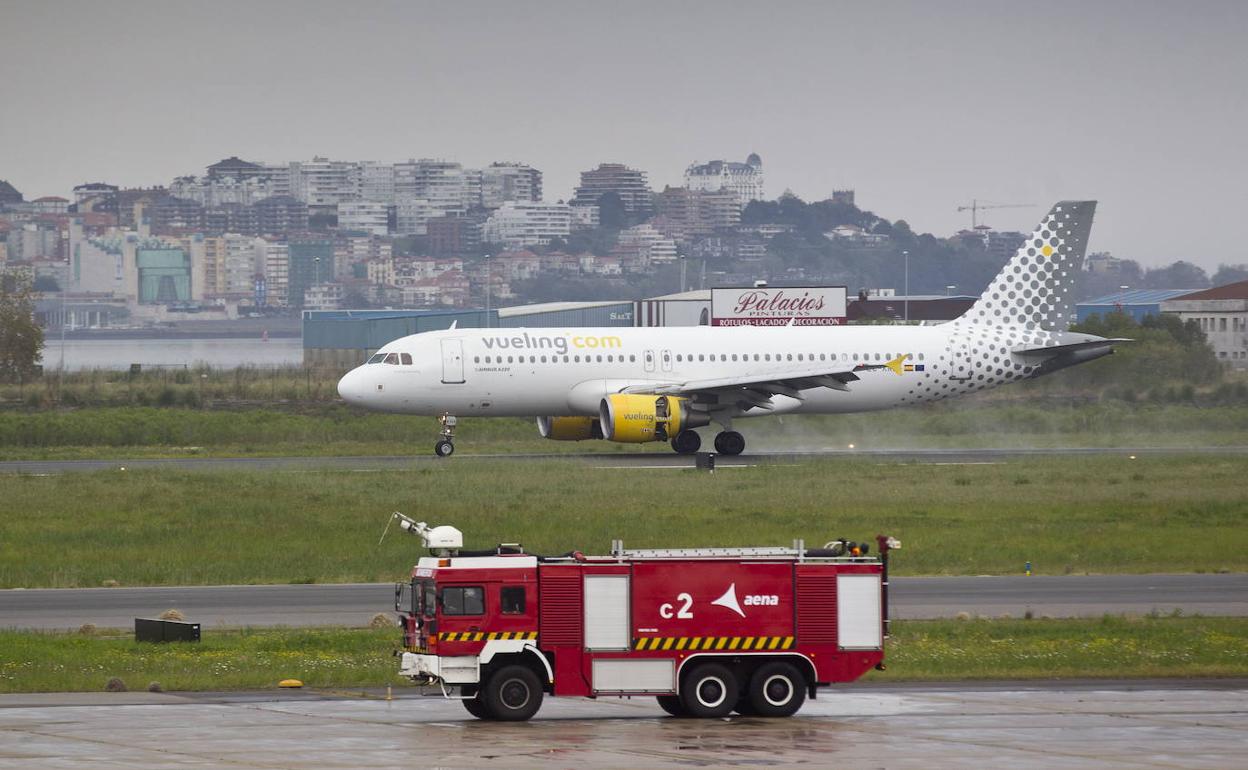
[{"x1": 0, "y1": 446, "x2": 1248, "y2": 474}]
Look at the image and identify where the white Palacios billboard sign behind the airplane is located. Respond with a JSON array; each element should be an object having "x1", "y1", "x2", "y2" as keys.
[{"x1": 710, "y1": 286, "x2": 846, "y2": 326}]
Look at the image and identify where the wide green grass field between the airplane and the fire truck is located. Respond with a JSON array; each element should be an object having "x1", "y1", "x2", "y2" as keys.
[{"x1": 0, "y1": 454, "x2": 1248, "y2": 588}]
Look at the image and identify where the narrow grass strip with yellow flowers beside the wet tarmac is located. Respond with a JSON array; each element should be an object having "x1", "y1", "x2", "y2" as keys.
[{"x1": 0, "y1": 616, "x2": 1248, "y2": 693}]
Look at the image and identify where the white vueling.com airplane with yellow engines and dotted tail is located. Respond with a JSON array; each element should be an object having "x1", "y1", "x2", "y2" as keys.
[{"x1": 338, "y1": 201, "x2": 1129, "y2": 457}]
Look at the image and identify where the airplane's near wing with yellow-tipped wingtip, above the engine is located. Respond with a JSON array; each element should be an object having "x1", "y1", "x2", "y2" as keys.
[{"x1": 623, "y1": 356, "x2": 906, "y2": 409}]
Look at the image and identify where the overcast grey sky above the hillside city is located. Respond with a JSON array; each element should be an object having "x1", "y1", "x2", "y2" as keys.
[{"x1": 0, "y1": 0, "x2": 1248, "y2": 271}]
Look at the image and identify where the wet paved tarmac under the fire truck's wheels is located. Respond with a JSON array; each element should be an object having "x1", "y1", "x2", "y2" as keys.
[{"x1": 0, "y1": 680, "x2": 1248, "y2": 770}]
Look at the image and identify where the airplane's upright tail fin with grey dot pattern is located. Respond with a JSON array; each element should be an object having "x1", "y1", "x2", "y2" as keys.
[{"x1": 960, "y1": 201, "x2": 1096, "y2": 331}]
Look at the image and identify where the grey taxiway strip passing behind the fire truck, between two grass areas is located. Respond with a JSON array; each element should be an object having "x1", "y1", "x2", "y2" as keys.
[{"x1": 0, "y1": 574, "x2": 1248, "y2": 629}]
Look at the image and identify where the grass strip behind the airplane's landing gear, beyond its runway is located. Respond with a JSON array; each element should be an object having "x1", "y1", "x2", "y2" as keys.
[{"x1": 0, "y1": 399, "x2": 1248, "y2": 459}]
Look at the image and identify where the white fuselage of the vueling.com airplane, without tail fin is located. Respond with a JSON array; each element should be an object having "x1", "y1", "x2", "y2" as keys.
[{"x1": 339, "y1": 322, "x2": 1037, "y2": 417}]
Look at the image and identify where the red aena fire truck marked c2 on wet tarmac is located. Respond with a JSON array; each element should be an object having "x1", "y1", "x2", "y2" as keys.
[{"x1": 392, "y1": 513, "x2": 901, "y2": 721}]
